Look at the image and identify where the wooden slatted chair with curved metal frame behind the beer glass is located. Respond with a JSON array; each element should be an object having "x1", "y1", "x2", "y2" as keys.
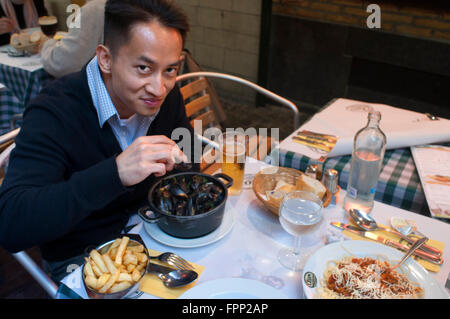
[{"x1": 177, "y1": 72, "x2": 300, "y2": 174}]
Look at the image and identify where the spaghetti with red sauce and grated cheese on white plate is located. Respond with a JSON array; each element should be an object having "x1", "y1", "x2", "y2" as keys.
[{"x1": 318, "y1": 257, "x2": 424, "y2": 299}]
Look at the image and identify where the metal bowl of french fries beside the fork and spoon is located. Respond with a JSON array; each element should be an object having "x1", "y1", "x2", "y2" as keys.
[{"x1": 82, "y1": 236, "x2": 149, "y2": 299}]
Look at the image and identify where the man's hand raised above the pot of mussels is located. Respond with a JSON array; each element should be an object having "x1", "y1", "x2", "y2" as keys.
[{"x1": 116, "y1": 135, "x2": 187, "y2": 186}]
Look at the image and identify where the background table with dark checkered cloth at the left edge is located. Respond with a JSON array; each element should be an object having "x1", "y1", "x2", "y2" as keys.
[{"x1": 0, "y1": 45, "x2": 53, "y2": 129}]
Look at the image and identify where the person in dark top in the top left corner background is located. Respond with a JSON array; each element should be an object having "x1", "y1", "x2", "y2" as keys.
[{"x1": 0, "y1": 0, "x2": 47, "y2": 45}]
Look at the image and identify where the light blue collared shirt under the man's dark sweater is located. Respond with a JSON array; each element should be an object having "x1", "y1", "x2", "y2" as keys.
[{"x1": 86, "y1": 56, "x2": 159, "y2": 150}]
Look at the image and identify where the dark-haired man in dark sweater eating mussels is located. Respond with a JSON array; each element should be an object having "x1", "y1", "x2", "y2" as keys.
[{"x1": 0, "y1": 0, "x2": 198, "y2": 280}]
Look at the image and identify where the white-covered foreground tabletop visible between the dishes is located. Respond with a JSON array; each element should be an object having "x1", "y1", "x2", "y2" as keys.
[{"x1": 63, "y1": 159, "x2": 450, "y2": 299}]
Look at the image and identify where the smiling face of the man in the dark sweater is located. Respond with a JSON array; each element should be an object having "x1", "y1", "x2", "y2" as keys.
[{"x1": 105, "y1": 21, "x2": 182, "y2": 118}]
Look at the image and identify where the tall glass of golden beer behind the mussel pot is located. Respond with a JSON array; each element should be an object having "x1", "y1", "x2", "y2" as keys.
[{"x1": 218, "y1": 131, "x2": 247, "y2": 196}]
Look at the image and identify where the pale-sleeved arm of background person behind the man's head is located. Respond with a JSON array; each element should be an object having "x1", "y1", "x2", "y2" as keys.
[{"x1": 41, "y1": 0, "x2": 106, "y2": 78}]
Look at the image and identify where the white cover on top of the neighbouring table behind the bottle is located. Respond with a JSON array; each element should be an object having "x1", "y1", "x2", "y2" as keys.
[{"x1": 280, "y1": 99, "x2": 450, "y2": 159}]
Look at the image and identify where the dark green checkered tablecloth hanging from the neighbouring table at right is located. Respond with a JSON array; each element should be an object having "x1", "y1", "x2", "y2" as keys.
[{"x1": 279, "y1": 148, "x2": 428, "y2": 215}]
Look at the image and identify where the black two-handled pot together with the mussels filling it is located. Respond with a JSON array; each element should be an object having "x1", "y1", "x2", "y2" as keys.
[{"x1": 139, "y1": 172, "x2": 233, "y2": 238}]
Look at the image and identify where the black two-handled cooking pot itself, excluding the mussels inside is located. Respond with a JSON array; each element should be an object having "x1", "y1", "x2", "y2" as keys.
[{"x1": 138, "y1": 172, "x2": 233, "y2": 238}]
